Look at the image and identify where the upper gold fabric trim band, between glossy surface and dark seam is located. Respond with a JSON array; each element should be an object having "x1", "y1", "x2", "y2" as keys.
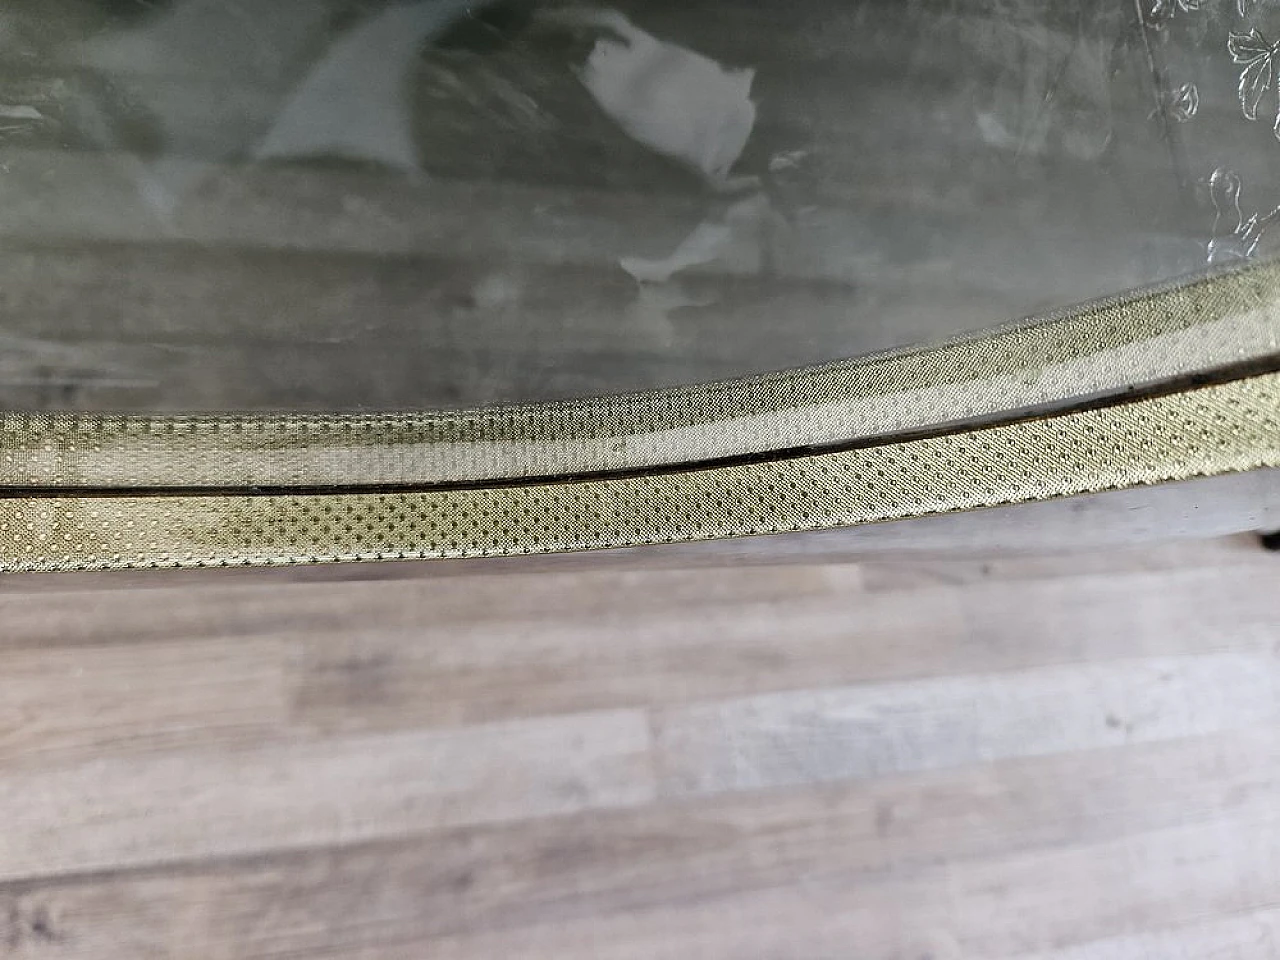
[{"x1": 0, "y1": 257, "x2": 1280, "y2": 488}]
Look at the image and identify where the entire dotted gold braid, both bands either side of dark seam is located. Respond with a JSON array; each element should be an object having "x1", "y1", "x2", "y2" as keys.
[{"x1": 0, "y1": 266, "x2": 1280, "y2": 571}]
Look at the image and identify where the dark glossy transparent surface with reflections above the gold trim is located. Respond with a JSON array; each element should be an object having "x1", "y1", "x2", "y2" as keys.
[{"x1": 0, "y1": 0, "x2": 1280, "y2": 410}]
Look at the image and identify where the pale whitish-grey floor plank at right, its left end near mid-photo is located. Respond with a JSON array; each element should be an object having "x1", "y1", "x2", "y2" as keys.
[{"x1": 655, "y1": 650, "x2": 1280, "y2": 796}]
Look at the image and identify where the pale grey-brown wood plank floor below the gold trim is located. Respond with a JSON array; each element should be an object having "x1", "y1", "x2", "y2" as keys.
[{"x1": 0, "y1": 538, "x2": 1280, "y2": 960}]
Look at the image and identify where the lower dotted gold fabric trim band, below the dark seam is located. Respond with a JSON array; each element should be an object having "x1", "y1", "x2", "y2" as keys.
[{"x1": 0, "y1": 374, "x2": 1280, "y2": 571}]
